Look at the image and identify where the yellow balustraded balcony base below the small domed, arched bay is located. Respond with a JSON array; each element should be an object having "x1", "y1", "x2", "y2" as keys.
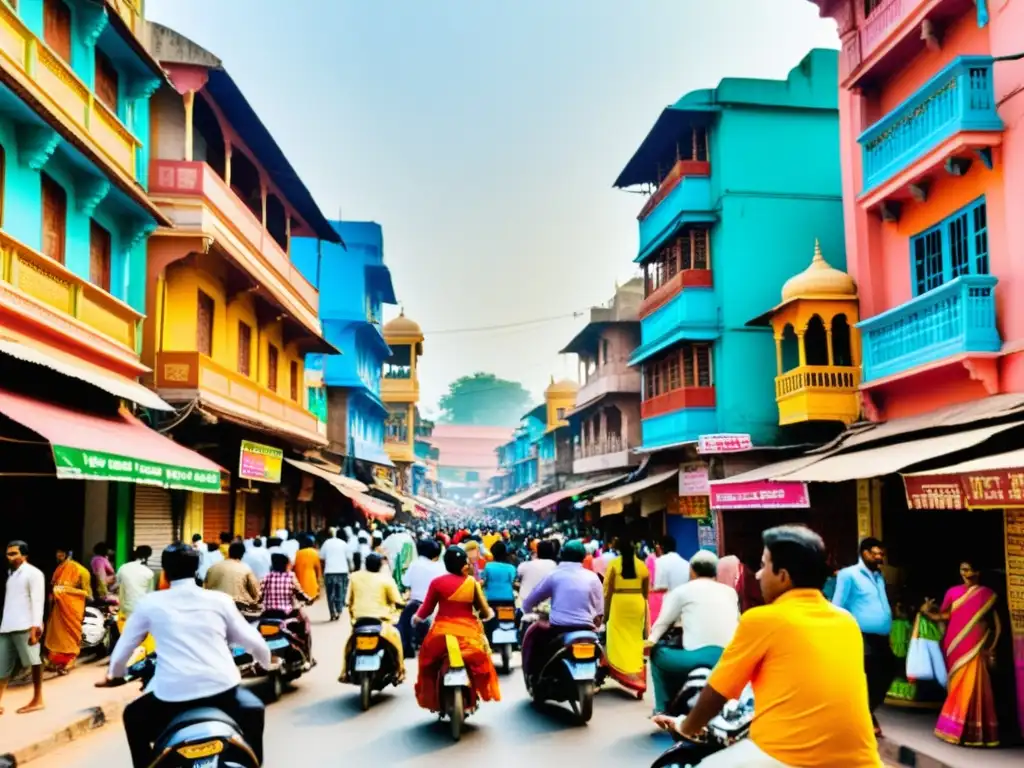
[{"x1": 775, "y1": 366, "x2": 860, "y2": 426}]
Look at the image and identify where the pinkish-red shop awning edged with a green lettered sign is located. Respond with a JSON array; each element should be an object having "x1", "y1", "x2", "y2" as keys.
[{"x1": 0, "y1": 389, "x2": 221, "y2": 494}]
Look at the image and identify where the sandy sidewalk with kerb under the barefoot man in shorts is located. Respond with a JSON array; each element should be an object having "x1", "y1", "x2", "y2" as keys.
[{"x1": 0, "y1": 660, "x2": 141, "y2": 765}]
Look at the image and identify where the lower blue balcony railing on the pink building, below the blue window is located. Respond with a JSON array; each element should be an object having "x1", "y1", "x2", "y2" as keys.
[{"x1": 857, "y1": 274, "x2": 1001, "y2": 382}]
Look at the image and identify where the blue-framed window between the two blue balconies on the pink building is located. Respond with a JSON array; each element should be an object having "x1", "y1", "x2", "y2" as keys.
[{"x1": 910, "y1": 198, "x2": 988, "y2": 296}]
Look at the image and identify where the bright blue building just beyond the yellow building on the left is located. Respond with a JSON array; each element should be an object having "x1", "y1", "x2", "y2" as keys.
[{"x1": 292, "y1": 221, "x2": 396, "y2": 472}]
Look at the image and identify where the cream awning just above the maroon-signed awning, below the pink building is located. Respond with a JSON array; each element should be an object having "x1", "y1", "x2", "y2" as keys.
[{"x1": 773, "y1": 422, "x2": 1024, "y2": 482}]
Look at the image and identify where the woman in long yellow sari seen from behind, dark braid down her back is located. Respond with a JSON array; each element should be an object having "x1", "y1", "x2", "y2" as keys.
[{"x1": 604, "y1": 536, "x2": 650, "y2": 698}]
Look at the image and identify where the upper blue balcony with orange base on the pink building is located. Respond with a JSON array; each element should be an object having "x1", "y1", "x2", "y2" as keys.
[{"x1": 857, "y1": 56, "x2": 1004, "y2": 205}]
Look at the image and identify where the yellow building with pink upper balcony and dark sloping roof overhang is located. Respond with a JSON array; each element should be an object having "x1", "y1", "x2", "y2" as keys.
[{"x1": 142, "y1": 25, "x2": 341, "y2": 541}]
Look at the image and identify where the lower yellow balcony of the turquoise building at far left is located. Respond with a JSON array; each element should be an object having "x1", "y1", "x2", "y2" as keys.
[{"x1": 0, "y1": 230, "x2": 146, "y2": 377}]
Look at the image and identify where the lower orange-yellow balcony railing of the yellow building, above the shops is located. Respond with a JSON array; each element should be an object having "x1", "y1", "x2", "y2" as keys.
[{"x1": 157, "y1": 352, "x2": 326, "y2": 442}]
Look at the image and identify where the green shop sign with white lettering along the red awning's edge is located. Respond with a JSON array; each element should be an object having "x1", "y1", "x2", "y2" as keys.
[{"x1": 53, "y1": 444, "x2": 220, "y2": 494}]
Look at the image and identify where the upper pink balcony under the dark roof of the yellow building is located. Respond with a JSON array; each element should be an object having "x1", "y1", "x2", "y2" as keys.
[{"x1": 150, "y1": 160, "x2": 321, "y2": 335}]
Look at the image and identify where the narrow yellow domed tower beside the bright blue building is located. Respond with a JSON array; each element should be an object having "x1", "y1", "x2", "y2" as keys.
[{"x1": 381, "y1": 310, "x2": 423, "y2": 481}]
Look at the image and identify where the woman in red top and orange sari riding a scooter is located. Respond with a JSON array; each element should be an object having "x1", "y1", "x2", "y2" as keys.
[{"x1": 413, "y1": 547, "x2": 502, "y2": 712}]
